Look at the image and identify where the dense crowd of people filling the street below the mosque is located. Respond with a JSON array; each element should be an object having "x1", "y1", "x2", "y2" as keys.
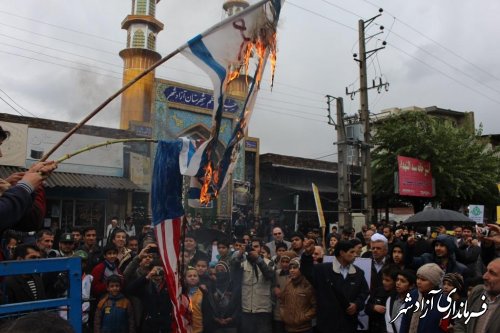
[{"x1": 0, "y1": 122, "x2": 500, "y2": 333}]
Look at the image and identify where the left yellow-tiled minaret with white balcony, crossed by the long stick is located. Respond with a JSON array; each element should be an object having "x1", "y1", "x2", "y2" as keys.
[{"x1": 120, "y1": 0, "x2": 163, "y2": 129}]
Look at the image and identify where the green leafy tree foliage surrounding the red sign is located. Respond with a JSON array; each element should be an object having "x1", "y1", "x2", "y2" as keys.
[{"x1": 372, "y1": 112, "x2": 500, "y2": 208}]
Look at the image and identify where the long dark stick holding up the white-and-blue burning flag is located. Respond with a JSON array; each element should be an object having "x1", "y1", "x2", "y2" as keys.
[{"x1": 40, "y1": 0, "x2": 269, "y2": 162}]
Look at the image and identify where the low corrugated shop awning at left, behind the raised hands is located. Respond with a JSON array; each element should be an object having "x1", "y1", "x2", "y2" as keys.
[{"x1": 0, "y1": 166, "x2": 144, "y2": 192}]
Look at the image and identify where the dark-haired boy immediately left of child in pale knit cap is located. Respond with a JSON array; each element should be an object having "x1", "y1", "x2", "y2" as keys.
[{"x1": 385, "y1": 269, "x2": 417, "y2": 333}]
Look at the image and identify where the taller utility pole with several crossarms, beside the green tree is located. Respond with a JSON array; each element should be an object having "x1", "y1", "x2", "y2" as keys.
[{"x1": 346, "y1": 9, "x2": 389, "y2": 225}]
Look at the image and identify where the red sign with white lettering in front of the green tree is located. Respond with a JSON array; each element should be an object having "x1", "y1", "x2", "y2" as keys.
[{"x1": 398, "y1": 156, "x2": 433, "y2": 198}]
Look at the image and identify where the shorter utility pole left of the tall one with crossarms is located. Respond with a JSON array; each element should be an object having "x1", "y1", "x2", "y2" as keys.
[{"x1": 326, "y1": 95, "x2": 352, "y2": 230}]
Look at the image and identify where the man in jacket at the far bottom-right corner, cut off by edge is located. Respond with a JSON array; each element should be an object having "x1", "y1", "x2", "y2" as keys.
[{"x1": 454, "y1": 258, "x2": 500, "y2": 333}]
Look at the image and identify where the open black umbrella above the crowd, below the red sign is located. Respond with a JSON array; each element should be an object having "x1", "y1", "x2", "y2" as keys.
[{"x1": 403, "y1": 208, "x2": 476, "y2": 227}]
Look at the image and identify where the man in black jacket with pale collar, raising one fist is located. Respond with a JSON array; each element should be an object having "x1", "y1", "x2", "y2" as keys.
[{"x1": 300, "y1": 240, "x2": 369, "y2": 333}]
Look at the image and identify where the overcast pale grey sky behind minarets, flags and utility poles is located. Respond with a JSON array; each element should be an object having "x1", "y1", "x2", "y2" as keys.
[{"x1": 0, "y1": 0, "x2": 500, "y2": 161}]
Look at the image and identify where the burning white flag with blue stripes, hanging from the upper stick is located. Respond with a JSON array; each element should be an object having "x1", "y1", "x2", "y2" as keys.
[{"x1": 182, "y1": 0, "x2": 284, "y2": 204}]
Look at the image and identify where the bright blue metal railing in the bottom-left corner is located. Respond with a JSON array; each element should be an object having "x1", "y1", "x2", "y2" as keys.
[{"x1": 0, "y1": 257, "x2": 82, "y2": 333}]
